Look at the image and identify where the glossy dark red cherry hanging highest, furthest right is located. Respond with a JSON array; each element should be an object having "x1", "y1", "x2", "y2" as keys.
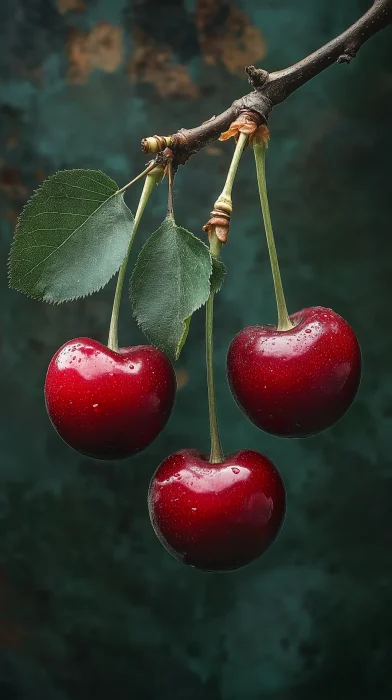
[{"x1": 227, "y1": 306, "x2": 361, "y2": 437}]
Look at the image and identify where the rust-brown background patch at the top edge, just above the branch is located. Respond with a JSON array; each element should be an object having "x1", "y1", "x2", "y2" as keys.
[{"x1": 196, "y1": 0, "x2": 266, "y2": 75}]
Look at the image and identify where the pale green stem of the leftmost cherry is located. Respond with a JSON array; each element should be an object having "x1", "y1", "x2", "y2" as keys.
[{"x1": 108, "y1": 165, "x2": 163, "y2": 352}]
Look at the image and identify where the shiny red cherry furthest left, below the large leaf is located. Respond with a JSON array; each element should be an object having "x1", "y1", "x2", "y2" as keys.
[{"x1": 45, "y1": 338, "x2": 176, "y2": 459}]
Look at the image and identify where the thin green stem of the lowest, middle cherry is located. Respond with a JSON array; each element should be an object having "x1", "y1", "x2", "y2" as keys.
[{"x1": 206, "y1": 233, "x2": 224, "y2": 464}]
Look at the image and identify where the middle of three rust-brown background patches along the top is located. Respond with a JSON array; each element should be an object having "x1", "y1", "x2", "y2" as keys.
[{"x1": 128, "y1": 28, "x2": 199, "y2": 99}]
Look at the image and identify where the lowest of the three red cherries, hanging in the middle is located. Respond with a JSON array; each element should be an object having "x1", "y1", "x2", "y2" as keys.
[{"x1": 148, "y1": 450, "x2": 286, "y2": 571}]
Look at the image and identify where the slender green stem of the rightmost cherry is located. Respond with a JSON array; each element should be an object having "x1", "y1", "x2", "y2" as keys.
[{"x1": 253, "y1": 141, "x2": 294, "y2": 331}]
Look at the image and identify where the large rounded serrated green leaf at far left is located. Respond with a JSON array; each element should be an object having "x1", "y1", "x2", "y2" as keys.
[{"x1": 9, "y1": 170, "x2": 133, "y2": 303}]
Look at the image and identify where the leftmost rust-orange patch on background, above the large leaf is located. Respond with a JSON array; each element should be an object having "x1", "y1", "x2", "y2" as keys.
[{"x1": 67, "y1": 22, "x2": 124, "y2": 85}]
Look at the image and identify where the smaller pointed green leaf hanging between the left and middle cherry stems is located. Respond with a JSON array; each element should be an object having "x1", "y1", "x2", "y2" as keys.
[{"x1": 131, "y1": 217, "x2": 212, "y2": 359}]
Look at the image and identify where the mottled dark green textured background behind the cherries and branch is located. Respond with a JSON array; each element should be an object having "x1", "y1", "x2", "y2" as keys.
[{"x1": 0, "y1": 0, "x2": 392, "y2": 700}]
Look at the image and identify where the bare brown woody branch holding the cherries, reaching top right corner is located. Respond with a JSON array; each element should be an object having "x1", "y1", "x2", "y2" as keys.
[{"x1": 142, "y1": 0, "x2": 392, "y2": 167}]
